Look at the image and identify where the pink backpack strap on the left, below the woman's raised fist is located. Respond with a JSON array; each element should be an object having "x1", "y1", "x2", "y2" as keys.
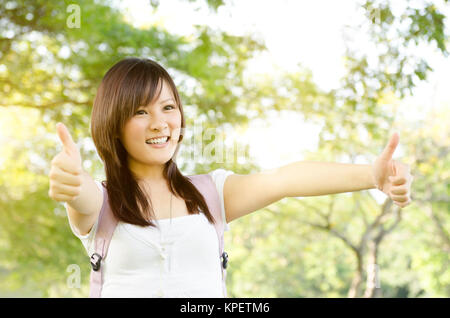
[{"x1": 89, "y1": 186, "x2": 117, "y2": 298}]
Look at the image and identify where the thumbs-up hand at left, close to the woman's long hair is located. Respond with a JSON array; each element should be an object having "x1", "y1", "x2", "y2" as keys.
[{"x1": 48, "y1": 123, "x2": 82, "y2": 202}]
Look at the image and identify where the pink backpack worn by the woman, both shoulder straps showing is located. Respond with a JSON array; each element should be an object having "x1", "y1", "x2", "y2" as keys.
[{"x1": 89, "y1": 174, "x2": 228, "y2": 298}]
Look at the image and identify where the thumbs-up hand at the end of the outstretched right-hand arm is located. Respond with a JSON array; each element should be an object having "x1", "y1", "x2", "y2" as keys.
[{"x1": 372, "y1": 133, "x2": 413, "y2": 208}]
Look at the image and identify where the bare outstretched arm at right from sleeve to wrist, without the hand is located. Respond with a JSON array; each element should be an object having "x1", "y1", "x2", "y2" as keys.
[{"x1": 223, "y1": 161, "x2": 375, "y2": 222}]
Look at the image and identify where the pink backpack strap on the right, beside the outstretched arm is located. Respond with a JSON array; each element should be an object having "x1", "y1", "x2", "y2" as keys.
[{"x1": 188, "y1": 174, "x2": 228, "y2": 297}]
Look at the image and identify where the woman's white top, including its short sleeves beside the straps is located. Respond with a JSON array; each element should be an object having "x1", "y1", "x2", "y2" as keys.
[{"x1": 69, "y1": 169, "x2": 233, "y2": 298}]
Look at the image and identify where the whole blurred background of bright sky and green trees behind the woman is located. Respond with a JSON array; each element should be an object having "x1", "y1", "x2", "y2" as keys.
[{"x1": 0, "y1": 0, "x2": 450, "y2": 298}]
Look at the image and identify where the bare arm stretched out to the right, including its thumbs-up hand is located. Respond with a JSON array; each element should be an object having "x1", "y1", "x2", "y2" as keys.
[{"x1": 224, "y1": 134, "x2": 413, "y2": 222}]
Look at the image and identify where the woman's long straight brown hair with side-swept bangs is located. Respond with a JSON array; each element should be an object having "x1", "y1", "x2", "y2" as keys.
[{"x1": 91, "y1": 57, "x2": 214, "y2": 226}]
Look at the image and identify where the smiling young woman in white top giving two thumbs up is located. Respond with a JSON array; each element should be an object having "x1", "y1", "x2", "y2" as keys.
[{"x1": 49, "y1": 58, "x2": 412, "y2": 297}]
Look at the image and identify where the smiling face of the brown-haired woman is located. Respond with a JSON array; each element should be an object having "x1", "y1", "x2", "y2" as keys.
[{"x1": 120, "y1": 82, "x2": 181, "y2": 174}]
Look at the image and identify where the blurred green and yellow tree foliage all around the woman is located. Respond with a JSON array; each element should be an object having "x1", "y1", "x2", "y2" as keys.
[{"x1": 0, "y1": 0, "x2": 450, "y2": 297}]
